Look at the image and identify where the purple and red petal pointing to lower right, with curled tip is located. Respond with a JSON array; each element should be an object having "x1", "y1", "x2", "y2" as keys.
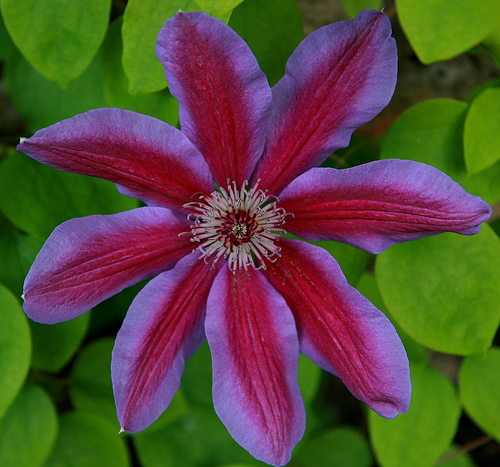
[{"x1": 263, "y1": 239, "x2": 411, "y2": 418}]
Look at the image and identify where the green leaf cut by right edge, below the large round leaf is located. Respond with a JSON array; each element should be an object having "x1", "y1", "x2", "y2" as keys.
[{"x1": 459, "y1": 347, "x2": 500, "y2": 442}]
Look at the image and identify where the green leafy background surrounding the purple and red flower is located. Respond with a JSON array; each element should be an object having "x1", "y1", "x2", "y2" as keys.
[{"x1": 0, "y1": 0, "x2": 500, "y2": 467}]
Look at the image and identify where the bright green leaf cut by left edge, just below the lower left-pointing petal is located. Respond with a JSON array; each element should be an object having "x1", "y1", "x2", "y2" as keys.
[{"x1": 0, "y1": 285, "x2": 31, "y2": 419}]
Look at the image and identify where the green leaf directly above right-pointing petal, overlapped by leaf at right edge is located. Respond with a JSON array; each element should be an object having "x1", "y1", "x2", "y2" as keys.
[{"x1": 380, "y1": 99, "x2": 500, "y2": 204}]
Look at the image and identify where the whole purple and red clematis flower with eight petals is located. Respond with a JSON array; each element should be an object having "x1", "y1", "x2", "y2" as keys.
[{"x1": 18, "y1": 11, "x2": 491, "y2": 465}]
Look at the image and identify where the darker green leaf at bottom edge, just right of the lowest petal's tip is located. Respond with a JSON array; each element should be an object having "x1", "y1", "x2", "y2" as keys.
[{"x1": 293, "y1": 427, "x2": 373, "y2": 467}]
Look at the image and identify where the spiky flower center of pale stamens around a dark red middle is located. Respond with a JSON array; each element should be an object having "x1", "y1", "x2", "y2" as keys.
[{"x1": 184, "y1": 180, "x2": 286, "y2": 272}]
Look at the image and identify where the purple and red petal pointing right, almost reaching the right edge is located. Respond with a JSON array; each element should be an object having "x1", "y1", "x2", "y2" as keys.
[{"x1": 280, "y1": 159, "x2": 491, "y2": 254}]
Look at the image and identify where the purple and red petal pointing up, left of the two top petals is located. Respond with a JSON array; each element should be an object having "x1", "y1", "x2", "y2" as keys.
[{"x1": 156, "y1": 13, "x2": 271, "y2": 186}]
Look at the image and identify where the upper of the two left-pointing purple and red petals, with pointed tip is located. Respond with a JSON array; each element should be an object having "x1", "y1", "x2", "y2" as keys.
[{"x1": 17, "y1": 109, "x2": 214, "y2": 212}]
